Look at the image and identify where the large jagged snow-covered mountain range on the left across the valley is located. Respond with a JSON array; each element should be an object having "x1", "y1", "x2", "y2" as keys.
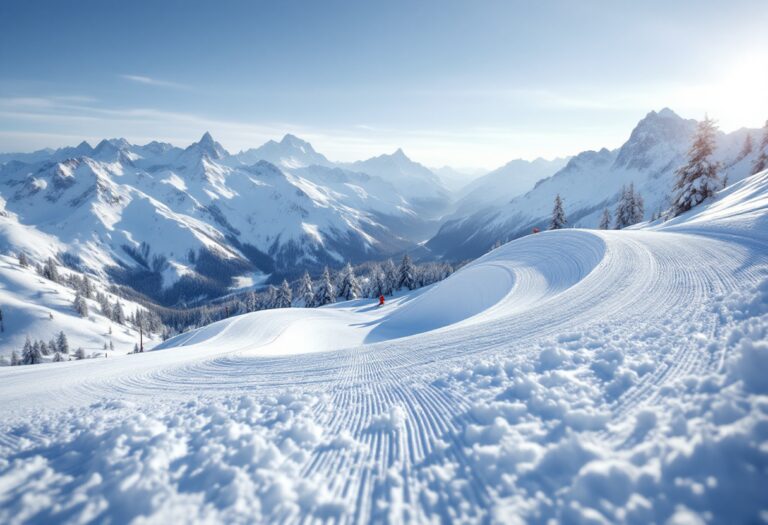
[{"x1": 0, "y1": 133, "x2": 436, "y2": 304}]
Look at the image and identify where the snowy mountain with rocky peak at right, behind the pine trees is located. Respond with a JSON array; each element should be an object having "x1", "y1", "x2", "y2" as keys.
[{"x1": 426, "y1": 108, "x2": 760, "y2": 260}]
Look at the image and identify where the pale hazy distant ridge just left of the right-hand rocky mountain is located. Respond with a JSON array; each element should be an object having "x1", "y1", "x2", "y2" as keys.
[{"x1": 452, "y1": 158, "x2": 568, "y2": 217}]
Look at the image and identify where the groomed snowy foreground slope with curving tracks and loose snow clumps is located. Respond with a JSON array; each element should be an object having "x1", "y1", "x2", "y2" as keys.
[{"x1": 0, "y1": 172, "x2": 768, "y2": 523}]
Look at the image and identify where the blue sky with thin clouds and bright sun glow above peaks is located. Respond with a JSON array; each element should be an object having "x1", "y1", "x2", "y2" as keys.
[{"x1": 0, "y1": 0, "x2": 768, "y2": 168}]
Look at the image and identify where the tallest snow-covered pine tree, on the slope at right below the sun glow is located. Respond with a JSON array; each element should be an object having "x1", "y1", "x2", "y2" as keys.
[{"x1": 672, "y1": 117, "x2": 720, "y2": 217}]
